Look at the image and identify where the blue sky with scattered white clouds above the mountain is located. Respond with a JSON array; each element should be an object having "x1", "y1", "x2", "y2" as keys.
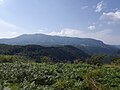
[{"x1": 0, "y1": 0, "x2": 120, "y2": 44}]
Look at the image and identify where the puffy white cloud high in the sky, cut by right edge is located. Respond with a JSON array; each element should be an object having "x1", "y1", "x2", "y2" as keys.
[{"x1": 100, "y1": 10, "x2": 120, "y2": 23}]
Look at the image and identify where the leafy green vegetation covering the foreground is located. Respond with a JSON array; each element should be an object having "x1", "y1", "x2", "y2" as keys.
[{"x1": 0, "y1": 55, "x2": 120, "y2": 90}]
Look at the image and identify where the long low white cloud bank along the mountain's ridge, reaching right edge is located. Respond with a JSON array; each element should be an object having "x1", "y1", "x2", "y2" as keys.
[{"x1": 47, "y1": 28, "x2": 120, "y2": 44}]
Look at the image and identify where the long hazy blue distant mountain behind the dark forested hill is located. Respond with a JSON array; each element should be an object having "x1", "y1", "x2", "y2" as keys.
[{"x1": 0, "y1": 34, "x2": 118, "y2": 54}]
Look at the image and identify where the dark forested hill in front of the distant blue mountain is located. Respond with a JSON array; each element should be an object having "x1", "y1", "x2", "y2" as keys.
[{"x1": 0, "y1": 45, "x2": 90, "y2": 62}]
